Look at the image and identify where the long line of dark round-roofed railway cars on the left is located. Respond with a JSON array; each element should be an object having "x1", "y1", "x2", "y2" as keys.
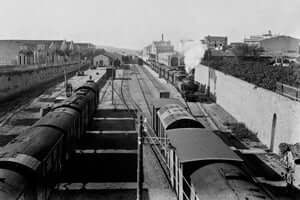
[{"x1": 0, "y1": 80, "x2": 99, "y2": 200}]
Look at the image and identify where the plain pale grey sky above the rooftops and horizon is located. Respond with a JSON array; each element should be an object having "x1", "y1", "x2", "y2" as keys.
[{"x1": 0, "y1": 0, "x2": 300, "y2": 49}]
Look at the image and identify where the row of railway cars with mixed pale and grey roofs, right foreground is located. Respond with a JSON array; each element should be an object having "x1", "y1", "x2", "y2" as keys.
[{"x1": 151, "y1": 99, "x2": 271, "y2": 200}]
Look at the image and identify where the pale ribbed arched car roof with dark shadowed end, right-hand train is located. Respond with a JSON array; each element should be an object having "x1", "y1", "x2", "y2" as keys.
[{"x1": 157, "y1": 104, "x2": 204, "y2": 130}]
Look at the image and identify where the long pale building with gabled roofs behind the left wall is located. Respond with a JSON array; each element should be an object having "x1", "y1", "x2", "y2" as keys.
[{"x1": 0, "y1": 40, "x2": 80, "y2": 66}]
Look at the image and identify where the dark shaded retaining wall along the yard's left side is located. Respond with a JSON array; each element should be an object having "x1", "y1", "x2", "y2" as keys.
[{"x1": 0, "y1": 64, "x2": 82, "y2": 102}]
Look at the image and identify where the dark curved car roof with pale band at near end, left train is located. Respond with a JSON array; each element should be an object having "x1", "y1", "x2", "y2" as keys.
[{"x1": 0, "y1": 127, "x2": 63, "y2": 171}]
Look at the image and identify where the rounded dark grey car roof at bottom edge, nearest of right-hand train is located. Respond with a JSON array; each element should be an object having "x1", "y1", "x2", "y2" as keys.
[{"x1": 190, "y1": 163, "x2": 270, "y2": 200}]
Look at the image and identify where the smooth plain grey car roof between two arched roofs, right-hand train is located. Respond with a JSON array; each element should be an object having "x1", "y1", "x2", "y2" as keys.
[{"x1": 166, "y1": 128, "x2": 243, "y2": 163}]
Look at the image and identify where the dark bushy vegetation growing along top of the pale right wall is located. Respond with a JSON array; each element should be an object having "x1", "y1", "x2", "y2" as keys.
[{"x1": 201, "y1": 50, "x2": 300, "y2": 91}]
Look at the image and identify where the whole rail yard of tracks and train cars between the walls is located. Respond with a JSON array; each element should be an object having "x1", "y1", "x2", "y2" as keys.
[{"x1": 0, "y1": 55, "x2": 298, "y2": 200}]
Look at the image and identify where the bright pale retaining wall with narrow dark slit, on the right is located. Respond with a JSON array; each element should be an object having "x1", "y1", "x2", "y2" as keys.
[{"x1": 195, "y1": 65, "x2": 300, "y2": 152}]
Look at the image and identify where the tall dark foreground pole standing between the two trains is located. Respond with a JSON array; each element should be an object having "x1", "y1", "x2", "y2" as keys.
[{"x1": 136, "y1": 115, "x2": 144, "y2": 200}]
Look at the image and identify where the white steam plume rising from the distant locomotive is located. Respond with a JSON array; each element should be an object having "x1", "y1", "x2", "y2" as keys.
[{"x1": 182, "y1": 41, "x2": 206, "y2": 73}]
